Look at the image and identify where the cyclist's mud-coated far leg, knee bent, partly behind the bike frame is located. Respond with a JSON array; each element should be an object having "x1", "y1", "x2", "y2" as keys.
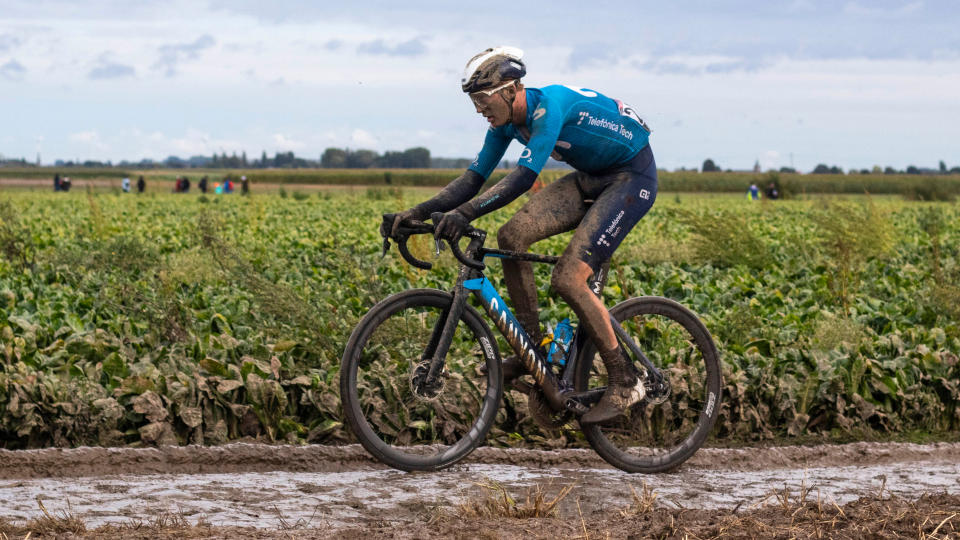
[{"x1": 497, "y1": 173, "x2": 587, "y2": 345}]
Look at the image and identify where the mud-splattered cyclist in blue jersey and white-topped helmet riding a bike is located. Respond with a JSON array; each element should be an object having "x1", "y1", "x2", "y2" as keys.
[{"x1": 381, "y1": 47, "x2": 657, "y2": 423}]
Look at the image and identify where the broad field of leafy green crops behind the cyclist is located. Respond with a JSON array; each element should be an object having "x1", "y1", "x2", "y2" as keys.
[{"x1": 0, "y1": 188, "x2": 960, "y2": 448}]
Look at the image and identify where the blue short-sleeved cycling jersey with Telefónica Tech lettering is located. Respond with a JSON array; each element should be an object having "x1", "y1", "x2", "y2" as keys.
[{"x1": 470, "y1": 85, "x2": 650, "y2": 178}]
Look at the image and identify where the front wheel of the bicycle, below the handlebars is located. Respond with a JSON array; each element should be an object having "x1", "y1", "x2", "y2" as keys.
[{"x1": 340, "y1": 289, "x2": 503, "y2": 471}]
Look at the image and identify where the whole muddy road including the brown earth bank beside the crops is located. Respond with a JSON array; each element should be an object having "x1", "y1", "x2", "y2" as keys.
[{"x1": 0, "y1": 443, "x2": 960, "y2": 533}]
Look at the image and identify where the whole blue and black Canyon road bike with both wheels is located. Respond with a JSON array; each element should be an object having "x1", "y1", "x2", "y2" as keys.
[{"x1": 340, "y1": 214, "x2": 722, "y2": 473}]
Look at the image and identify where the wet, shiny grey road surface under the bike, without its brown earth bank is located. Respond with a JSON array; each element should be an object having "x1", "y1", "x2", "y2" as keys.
[{"x1": 0, "y1": 460, "x2": 960, "y2": 528}]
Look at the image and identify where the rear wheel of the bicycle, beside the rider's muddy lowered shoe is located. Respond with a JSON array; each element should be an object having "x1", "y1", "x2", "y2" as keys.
[{"x1": 574, "y1": 296, "x2": 722, "y2": 473}]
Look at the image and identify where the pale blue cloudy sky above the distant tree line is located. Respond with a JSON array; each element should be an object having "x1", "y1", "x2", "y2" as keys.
[{"x1": 0, "y1": 0, "x2": 960, "y2": 170}]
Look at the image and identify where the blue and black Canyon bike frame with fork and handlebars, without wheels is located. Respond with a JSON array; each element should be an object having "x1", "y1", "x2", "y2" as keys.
[{"x1": 383, "y1": 214, "x2": 669, "y2": 417}]
